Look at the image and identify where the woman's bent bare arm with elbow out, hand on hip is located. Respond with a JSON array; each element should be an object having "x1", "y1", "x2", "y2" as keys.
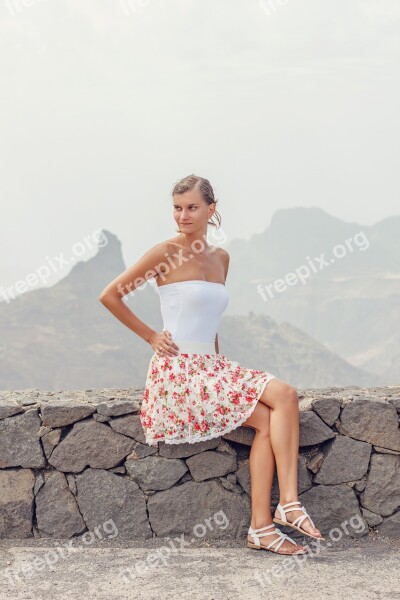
[{"x1": 99, "y1": 242, "x2": 167, "y2": 343}]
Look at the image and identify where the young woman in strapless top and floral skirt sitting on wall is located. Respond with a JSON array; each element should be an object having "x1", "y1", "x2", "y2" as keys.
[{"x1": 100, "y1": 175, "x2": 324, "y2": 555}]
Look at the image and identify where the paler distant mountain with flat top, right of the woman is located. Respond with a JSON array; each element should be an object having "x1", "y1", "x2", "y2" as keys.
[{"x1": 226, "y1": 207, "x2": 400, "y2": 384}]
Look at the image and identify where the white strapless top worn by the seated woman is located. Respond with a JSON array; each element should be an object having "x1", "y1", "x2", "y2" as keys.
[{"x1": 158, "y1": 279, "x2": 229, "y2": 352}]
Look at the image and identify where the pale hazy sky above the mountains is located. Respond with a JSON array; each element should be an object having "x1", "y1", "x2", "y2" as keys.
[{"x1": 0, "y1": 0, "x2": 400, "y2": 292}]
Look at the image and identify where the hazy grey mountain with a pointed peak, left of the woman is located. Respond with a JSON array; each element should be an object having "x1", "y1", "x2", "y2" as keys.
[{"x1": 0, "y1": 231, "x2": 162, "y2": 390}]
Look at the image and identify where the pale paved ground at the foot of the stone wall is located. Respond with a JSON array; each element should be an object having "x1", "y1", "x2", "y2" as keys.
[{"x1": 0, "y1": 534, "x2": 400, "y2": 600}]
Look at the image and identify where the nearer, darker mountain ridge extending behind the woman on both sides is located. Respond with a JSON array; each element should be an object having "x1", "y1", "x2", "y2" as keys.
[{"x1": 0, "y1": 225, "x2": 380, "y2": 391}]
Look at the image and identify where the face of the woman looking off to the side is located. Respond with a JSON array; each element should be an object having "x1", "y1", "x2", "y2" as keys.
[{"x1": 173, "y1": 190, "x2": 215, "y2": 233}]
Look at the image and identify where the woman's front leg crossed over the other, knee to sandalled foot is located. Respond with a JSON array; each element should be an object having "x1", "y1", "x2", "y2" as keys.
[{"x1": 260, "y1": 378, "x2": 322, "y2": 537}]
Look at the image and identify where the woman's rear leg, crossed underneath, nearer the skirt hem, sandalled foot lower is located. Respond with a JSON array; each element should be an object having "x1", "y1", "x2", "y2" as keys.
[{"x1": 243, "y1": 398, "x2": 304, "y2": 553}]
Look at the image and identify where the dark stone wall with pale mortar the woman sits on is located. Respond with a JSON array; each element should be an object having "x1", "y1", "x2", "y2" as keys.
[{"x1": 0, "y1": 386, "x2": 400, "y2": 540}]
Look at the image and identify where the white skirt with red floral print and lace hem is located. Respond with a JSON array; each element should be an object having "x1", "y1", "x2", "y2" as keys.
[{"x1": 140, "y1": 353, "x2": 276, "y2": 446}]
